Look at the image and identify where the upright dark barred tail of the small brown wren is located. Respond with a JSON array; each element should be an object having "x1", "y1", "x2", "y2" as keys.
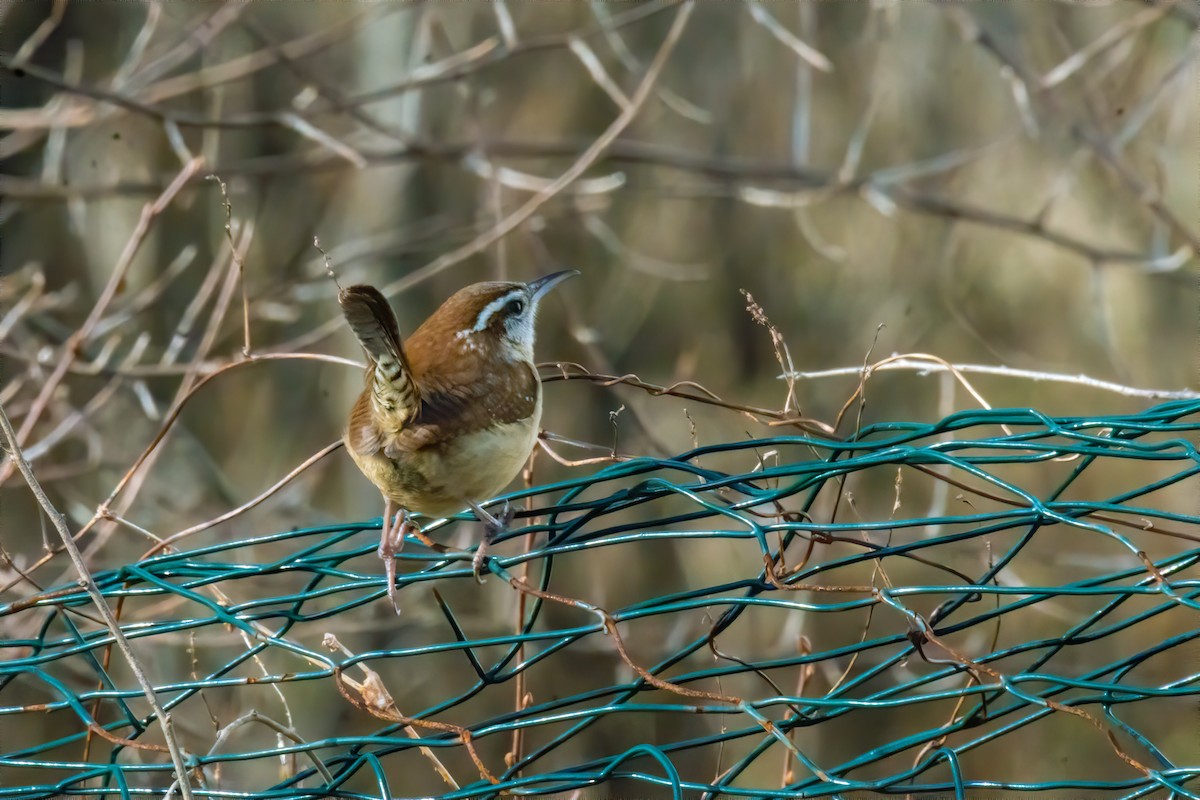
[{"x1": 337, "y1": 285, "x2": 421, "y2": 428}]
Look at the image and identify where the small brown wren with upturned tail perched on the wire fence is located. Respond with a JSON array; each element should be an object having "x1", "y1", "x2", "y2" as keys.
[{"x1": 337, "y1": 270, "x2": 578, "y2": 604}]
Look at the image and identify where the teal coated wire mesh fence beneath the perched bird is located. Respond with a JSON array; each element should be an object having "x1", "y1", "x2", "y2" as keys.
[{"x1": 0, "y1": 401, "x2": 1200, "y2": 800}]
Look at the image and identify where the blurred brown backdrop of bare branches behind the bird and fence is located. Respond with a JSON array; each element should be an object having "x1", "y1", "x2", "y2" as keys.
[{"x1": 0, "y1": 0, "x2": 1200, "y2": 792}]
